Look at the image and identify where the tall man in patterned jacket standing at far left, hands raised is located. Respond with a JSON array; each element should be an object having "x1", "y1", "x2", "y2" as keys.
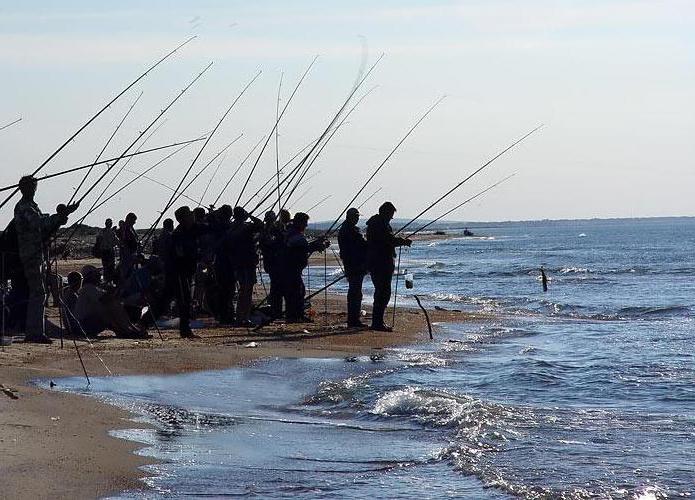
[{"x1": 14, "y1": 175, "x2": 79, "y2": 344}]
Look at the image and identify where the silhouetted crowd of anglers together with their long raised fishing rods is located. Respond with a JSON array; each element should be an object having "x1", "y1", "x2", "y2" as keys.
[{"x1": 0, "y1": 37, "x2": 541, "y2": 343}]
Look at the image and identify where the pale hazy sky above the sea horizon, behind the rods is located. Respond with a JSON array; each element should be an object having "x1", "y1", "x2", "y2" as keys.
[{"x1": 0, "y1": 0, "x2": 695, "y2": 226}]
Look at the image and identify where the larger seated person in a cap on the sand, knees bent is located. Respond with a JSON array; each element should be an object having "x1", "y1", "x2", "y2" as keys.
[{"x1": 75, "y1": 265, "x2": 150, "y2": 339}]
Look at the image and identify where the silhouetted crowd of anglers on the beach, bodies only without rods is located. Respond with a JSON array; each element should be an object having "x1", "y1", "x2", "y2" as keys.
[{"x1": 2, "y1": 176, "x2": 411, "y2": 343}]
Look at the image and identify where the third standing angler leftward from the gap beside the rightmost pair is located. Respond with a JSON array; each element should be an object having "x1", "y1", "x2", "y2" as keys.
[{"x1": 226, "y1": 207, "x2": 263, "y2": 327}]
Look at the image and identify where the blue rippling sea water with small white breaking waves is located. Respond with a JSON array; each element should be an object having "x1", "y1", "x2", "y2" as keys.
[{"x1": 51, "y1": 219, "x2": 695, "y2": 499}]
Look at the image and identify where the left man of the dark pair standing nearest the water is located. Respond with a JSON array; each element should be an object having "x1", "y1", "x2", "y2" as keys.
[{"x1": 338, "y1": 208, "x2": 367, "y2": 328}]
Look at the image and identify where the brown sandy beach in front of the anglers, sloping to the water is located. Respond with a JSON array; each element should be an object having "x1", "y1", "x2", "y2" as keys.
[{"x1": 0, "y1": 261, "x2": 472, "y2": 498}]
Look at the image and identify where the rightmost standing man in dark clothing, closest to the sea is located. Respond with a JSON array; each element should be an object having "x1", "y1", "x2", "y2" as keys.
[{"x1": 367, "y1": 201, "x2": 412, "y2": 332}]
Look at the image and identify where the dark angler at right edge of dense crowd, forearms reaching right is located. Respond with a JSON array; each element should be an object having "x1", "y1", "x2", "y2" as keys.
[{"x1": 283, "y1": 212, "x2": 330, "y2": 323}]
